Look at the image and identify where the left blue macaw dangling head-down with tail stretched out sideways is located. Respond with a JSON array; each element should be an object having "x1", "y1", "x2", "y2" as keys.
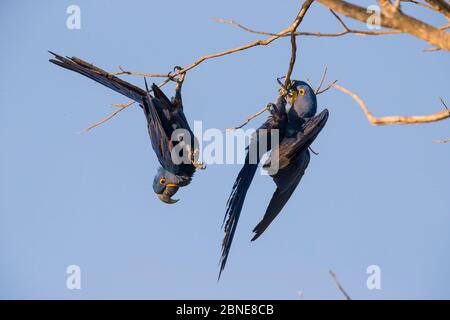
[{"x1": 50, "y1": 52, "x2": 204, "y2": 204}]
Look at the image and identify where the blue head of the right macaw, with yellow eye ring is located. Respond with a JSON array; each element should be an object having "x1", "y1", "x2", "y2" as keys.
[{"x1": 288, "y1": 80, "x2": 317, "y2": 119}]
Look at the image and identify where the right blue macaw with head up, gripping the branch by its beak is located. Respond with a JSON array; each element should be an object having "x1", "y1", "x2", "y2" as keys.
[{"x1": 219, "y1": 80, "x2": 328, "y2": 278}]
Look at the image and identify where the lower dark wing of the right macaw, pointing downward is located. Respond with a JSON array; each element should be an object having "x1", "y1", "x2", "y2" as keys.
[{"x1": 252, "y1": 150, "x2": 310, "y2": 241}]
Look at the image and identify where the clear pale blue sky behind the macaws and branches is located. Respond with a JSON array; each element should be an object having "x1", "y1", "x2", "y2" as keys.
[{"x1": 0, "y1": 0, "x2": 450, "y2": 299}]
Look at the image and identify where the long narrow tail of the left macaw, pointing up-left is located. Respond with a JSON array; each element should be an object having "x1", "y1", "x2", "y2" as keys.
[{"x1": 49, "y1": 51, "x2": 147, "y2": 103}]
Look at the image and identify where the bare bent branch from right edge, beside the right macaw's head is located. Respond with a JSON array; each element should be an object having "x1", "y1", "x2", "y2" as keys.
[{"x1": 333, "y1": 83, "x2": 450, "y2": 126}]
